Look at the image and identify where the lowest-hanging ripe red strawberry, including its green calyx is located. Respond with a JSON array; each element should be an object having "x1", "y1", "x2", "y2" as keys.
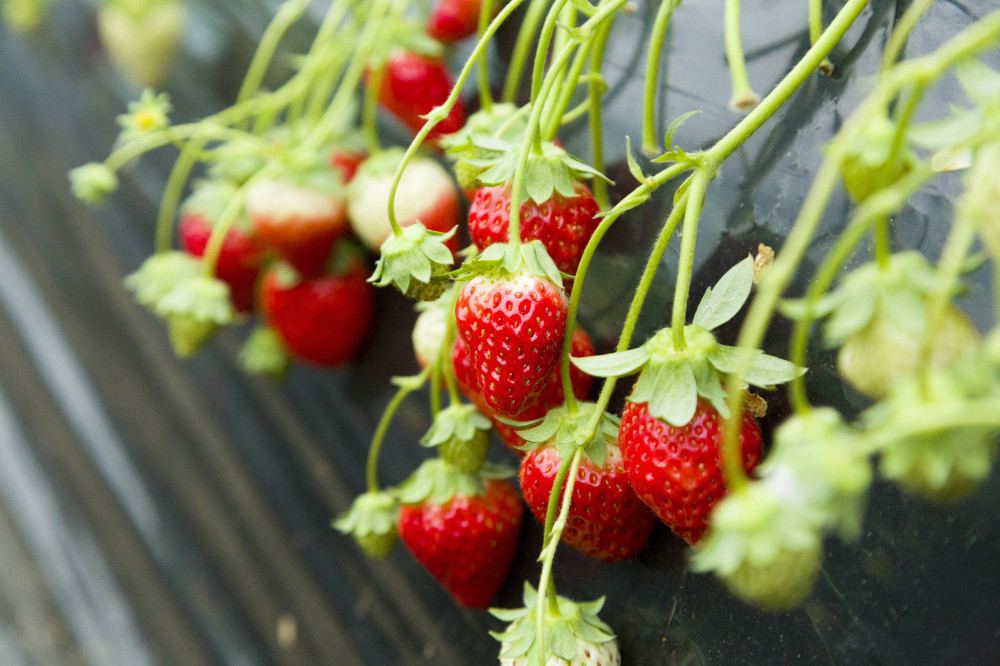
[{"x1": 398, "y1": 460, "x2": 524, "y2": 608}]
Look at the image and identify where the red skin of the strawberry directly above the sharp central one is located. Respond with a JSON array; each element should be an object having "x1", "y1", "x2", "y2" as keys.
[{"x1": 469, "y1": 182, "x2": 600, "y2": 275}]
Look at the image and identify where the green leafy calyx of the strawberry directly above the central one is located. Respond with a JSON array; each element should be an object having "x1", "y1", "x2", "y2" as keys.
[{"x1": 468, "y1": 137, "x2": 611, "y2": 204}]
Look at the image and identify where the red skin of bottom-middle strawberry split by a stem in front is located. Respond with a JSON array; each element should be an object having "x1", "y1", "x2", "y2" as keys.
[{"x1": 521, "y1": 445, "x2": 656, "y2": 562}]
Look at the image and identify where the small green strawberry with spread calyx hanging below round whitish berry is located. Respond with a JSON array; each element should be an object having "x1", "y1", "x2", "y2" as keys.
[{"x1": 368, "y1": 222, "x2": 458, "y2": 301}]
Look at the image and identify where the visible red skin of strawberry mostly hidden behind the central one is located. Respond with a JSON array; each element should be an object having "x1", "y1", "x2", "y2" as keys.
[{"x1": 451, "y1": 328, "x2": 594, "y2": 456}]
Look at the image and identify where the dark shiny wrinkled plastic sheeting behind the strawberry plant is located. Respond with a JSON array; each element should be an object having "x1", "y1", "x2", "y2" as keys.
[{"x1": 0, "y1": 0, "x2": 1000, "y2": 664}]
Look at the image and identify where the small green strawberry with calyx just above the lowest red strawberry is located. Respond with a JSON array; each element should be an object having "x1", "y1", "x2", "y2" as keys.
[{"x1": 420, "y1": 404, "x2": 493, "y2": 474}]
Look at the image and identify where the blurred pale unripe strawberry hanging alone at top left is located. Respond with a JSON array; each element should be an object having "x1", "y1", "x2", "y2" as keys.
[{"x1": 97, "y1": 0, "x2": 187, "y2": 88}]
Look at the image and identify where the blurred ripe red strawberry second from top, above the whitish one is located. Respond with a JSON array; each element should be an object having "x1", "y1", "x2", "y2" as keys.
[{"x1": 378, "y1": 49, "x2": 465, "y2": 142}]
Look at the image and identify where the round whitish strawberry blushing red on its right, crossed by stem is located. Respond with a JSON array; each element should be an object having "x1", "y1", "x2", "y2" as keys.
[{"x1": 347, "y1": 149, "x2": 461, "y2": 252}]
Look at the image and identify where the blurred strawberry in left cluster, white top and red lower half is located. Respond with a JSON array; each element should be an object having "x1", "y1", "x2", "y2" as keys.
[{"x1": 247, "y1": 158, "x2": 347, "y2": 277}]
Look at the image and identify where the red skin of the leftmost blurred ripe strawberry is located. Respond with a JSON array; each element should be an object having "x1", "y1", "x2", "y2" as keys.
[{"x1": 178, "y1": 213, "x2": 261, "y2": 313}]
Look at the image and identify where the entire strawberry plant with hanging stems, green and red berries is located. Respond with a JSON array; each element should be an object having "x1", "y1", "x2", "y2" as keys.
[{"x1": 64, "y1": 0, "x2": 1000, "y2": 664}]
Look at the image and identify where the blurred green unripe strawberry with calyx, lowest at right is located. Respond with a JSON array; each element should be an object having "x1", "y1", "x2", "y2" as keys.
[{"x1": 691, "y1": 475, "x2": 822, "y2": 611}]
